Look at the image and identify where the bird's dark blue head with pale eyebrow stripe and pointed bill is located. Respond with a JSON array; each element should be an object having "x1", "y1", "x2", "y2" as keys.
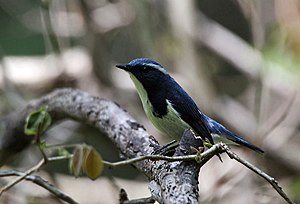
[{"x1": 116, "y1": 58, "x2": 169, "y2": 86}]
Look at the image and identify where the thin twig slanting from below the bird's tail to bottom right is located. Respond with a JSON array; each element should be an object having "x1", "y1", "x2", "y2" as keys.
[{"x1": 221, "y1": 143, "x2": 295, "y2": 204}]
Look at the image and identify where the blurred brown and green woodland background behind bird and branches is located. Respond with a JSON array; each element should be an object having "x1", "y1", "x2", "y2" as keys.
[{"x1": 0, "y1": 0, "x2": 300, "y2": 204}]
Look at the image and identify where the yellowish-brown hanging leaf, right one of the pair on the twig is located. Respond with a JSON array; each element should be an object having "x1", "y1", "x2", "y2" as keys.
[{"x1": 82, "y1": 147, "x2": 103, "y2": 180}]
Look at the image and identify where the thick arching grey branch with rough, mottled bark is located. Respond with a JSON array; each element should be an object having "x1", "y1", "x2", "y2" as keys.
[{"x1": 0, "y1": 89, "x2": 200, "y2": 203}]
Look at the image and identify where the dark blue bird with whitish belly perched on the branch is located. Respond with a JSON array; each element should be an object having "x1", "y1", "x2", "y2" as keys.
[{"x1": 116, "y1": 58, "x2": 264, "y2": 153}]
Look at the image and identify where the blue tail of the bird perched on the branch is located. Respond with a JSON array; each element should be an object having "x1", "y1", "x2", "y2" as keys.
[{"x1": 204, "y1": 115, "x2": 264, "y2": 153}]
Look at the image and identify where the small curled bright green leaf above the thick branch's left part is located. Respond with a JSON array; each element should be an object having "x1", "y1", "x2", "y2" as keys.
[{"x1": 24, "y1": 106, "x2": 51, "y2": 135}]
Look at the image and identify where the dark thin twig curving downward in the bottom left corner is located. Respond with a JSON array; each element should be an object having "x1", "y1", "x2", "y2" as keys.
[{"x1": 0, "y1": 170, "x2": 78, "y2": 204}]
